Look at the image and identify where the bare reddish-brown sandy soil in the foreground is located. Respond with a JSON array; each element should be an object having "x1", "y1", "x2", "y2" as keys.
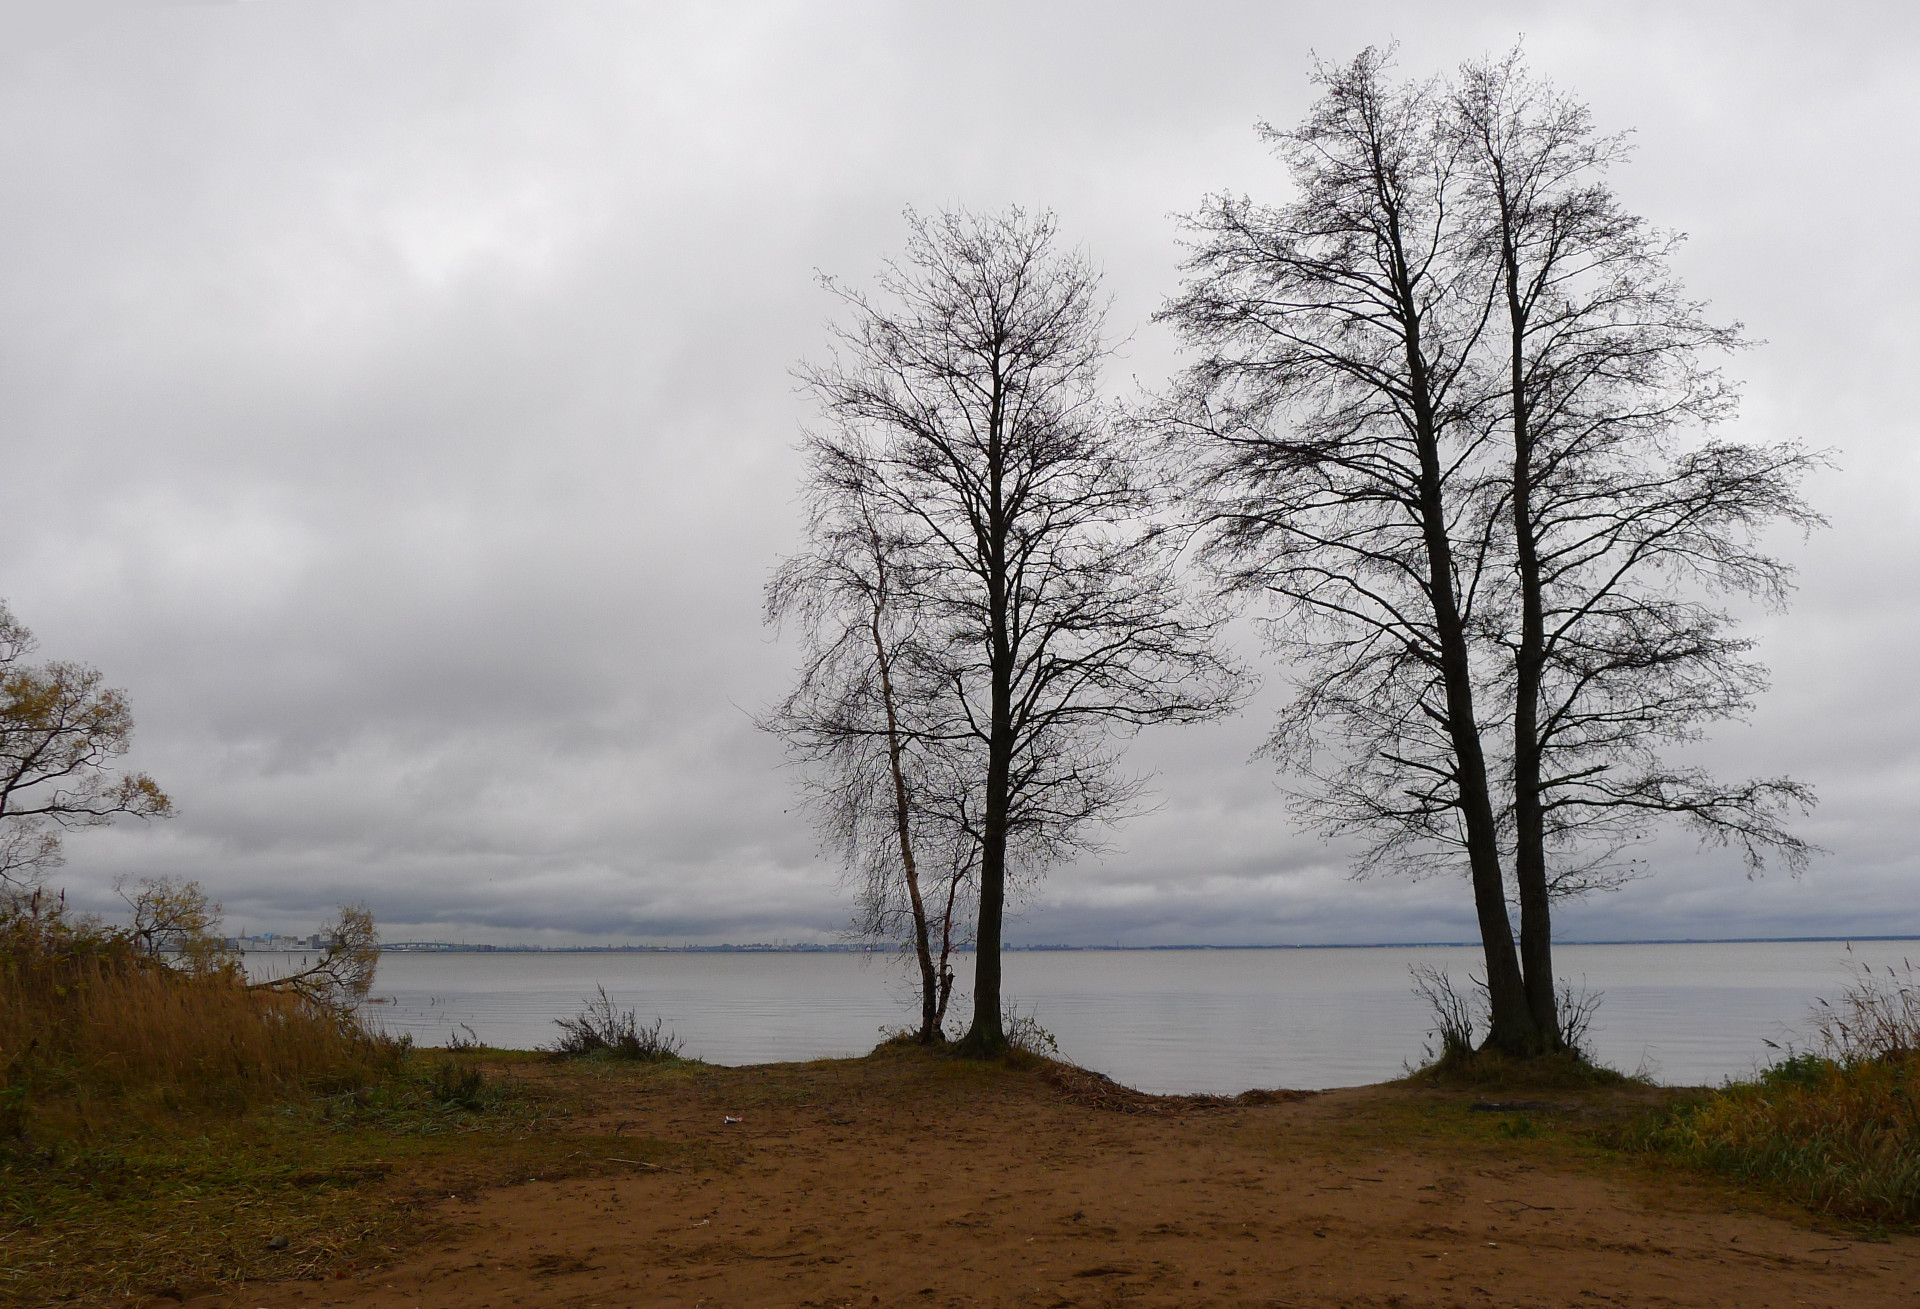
[{"x1": 176, "y1": 1052, "x2": 1920, "y2": 1309}]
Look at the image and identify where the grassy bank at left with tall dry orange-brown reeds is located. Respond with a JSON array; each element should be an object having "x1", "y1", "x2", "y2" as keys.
[{"x1": 0, "y1": 886, "x2": 637, "y2": 1305}]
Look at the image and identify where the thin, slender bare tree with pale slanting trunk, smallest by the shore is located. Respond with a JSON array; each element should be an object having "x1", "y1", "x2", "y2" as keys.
[{"x1": 758, "y1": 486, "x2": 979, "y2": 1044}]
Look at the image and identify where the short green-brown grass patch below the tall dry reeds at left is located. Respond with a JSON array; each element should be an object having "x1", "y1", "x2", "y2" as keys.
[{"x1": 0, "y1": 1054, "x2": 586, "y2": 1307}]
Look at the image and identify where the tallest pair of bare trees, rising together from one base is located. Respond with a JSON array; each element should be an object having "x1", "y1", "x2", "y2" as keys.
[{"x1": 1162, "y1": 50, "x2": 1814, "y2": 1054}]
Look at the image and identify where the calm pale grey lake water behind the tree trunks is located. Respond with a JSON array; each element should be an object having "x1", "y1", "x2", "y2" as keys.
[{"x1": 248, "y1": 942, "x2": 1920, "y2": 1092}]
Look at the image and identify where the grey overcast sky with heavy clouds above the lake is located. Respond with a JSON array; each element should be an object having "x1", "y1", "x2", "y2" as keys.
[{"x1": 0, "y1": 0, "x2": 1920, "y2": 942}]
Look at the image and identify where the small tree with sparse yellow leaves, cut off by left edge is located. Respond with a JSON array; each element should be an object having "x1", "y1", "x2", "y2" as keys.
[{"x1": 0, "y1": 603, "x2": 173, "y2": 891}]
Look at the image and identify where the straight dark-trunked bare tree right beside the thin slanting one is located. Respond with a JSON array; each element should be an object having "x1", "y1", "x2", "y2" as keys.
[{"x1": 803, "y1": 209, "x2": 1233, "y2": 1054}]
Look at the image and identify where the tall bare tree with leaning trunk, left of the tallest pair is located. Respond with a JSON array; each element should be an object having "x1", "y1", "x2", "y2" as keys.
[{"x1": 1160, "y1": 50, "x2": 1534, "y2": 1048}]
